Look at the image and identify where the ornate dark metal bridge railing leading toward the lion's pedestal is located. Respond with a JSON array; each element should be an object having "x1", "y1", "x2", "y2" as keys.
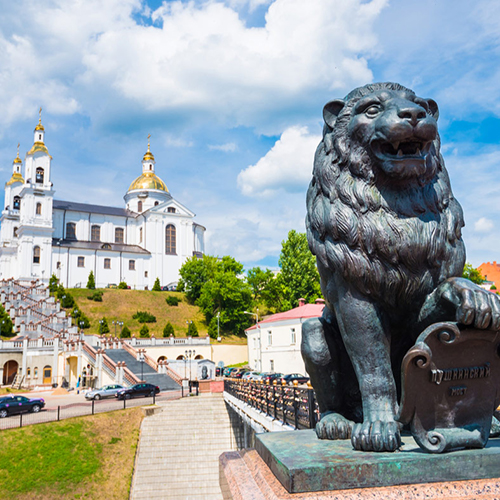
[{"x1": 224, "y1": 379, "x2": 319, "y2": 429}]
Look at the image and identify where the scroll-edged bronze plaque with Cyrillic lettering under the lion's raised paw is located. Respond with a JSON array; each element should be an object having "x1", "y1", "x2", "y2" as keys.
[{"x1": 398, "y1": 323, "x2": 500, "y2": 453}]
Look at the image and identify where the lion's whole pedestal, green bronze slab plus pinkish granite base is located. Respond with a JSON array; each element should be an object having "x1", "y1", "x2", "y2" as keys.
[{"x1": 220, "y1": 431, "x2": 500, "y2": 500}]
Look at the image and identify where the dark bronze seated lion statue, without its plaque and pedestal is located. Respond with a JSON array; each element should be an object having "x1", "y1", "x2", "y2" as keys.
[{"x1": 302, "y1": 83, "x2": 500, "y2": 451}]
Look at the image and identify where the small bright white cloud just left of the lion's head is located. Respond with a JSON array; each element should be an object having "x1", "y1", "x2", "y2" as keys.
[{"x1": 238, "y1": 127, "x2": 321, "y2": 196}]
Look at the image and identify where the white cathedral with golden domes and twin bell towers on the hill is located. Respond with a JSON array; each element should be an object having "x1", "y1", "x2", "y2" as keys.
[{"x1": 0, "y1": 117, "x2": 205, "y2": 289}]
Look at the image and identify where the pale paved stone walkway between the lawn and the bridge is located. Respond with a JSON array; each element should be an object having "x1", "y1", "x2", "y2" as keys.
[{"x1": 130, "y1": 394, "x2": 242, "y2": 500}]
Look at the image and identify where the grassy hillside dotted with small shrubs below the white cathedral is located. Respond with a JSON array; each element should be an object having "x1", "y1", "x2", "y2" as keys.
[{"x1": 68, "y1": 288, "x2": 207, "y2": 337}]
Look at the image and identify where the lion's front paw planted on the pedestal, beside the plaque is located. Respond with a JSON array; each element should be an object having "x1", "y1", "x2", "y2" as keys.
[{"x1": 351, "y1": 420, "x2": 401, "y2": 451}]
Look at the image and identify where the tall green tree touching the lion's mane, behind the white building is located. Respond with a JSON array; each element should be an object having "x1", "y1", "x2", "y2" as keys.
[{"x1": 276, "y1": 229, "x2": 321, "y2": 310}]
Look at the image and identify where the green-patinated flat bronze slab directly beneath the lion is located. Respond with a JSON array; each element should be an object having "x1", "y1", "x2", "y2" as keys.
[{"x1": 255, "y1": 430, "x2": 500, "y2": 493}]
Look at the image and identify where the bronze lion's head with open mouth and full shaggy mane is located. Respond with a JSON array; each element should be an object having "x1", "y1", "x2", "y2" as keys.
[{"x1": 306, "y1": 83, "x2": 465, "y2": 306}]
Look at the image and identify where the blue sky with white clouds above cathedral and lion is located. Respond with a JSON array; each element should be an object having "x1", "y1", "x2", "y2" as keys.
[{"x1": 0, "y1": 0, "x2": 500, "y2": 268}]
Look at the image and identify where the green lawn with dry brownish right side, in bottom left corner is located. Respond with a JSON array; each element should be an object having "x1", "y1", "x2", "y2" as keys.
[{"x1": 0, "y1": 408, "x2": 142, "y2": 500}]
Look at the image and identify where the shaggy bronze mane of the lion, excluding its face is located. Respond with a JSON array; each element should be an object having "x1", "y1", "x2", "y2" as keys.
[{"x1": 306, "y1": 83, "x2": 465, "y2": 307}]
